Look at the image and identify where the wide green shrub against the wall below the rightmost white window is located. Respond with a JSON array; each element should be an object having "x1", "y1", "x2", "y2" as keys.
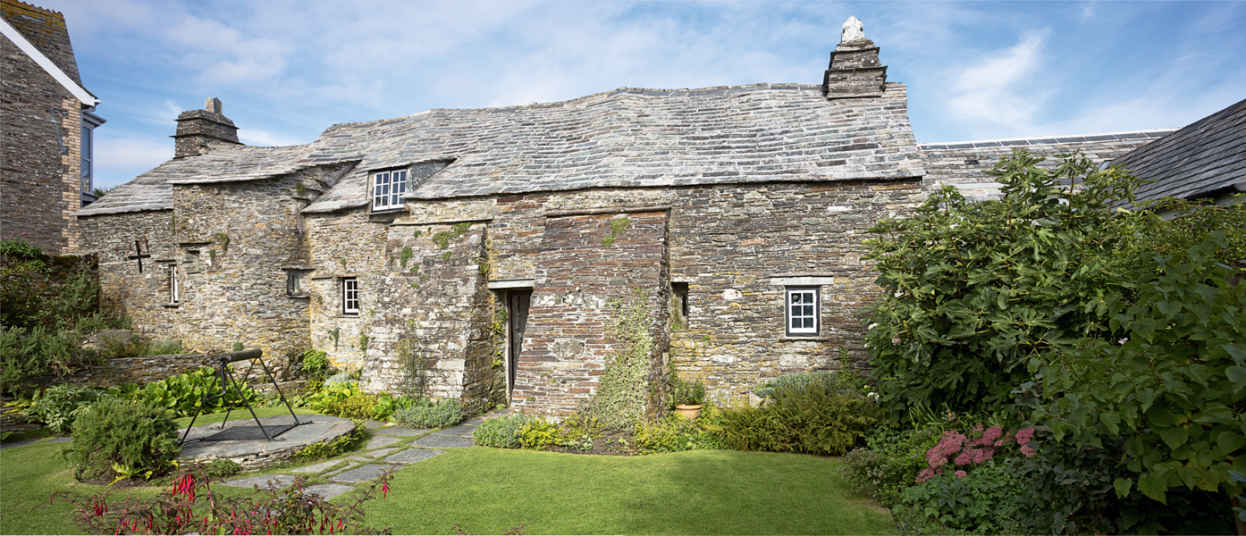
[{"x1": 723, "y1": 374, "x2": 882, "y2": 456}]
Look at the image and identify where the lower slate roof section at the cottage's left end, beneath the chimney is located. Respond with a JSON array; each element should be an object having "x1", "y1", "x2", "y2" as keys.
[{"x1": 78, "y1": 145, "x2": 316, "y2": 216}]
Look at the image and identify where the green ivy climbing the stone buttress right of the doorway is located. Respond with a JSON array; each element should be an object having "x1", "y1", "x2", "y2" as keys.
[{"x1": 589, "y1": 292, "x2": 654, "y2": 429}]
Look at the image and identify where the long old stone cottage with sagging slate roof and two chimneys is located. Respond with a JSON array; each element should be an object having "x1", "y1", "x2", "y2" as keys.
[{"x1": 78, "y1": 19, "x2": 1166, "y2": 415}]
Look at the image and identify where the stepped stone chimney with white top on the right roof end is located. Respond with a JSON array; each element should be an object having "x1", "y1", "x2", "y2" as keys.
[{"x1": 822, "y1": 16, "x2": 887, "y2": 98}]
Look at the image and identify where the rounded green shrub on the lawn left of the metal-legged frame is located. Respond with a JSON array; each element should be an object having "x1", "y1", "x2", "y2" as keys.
[{"x1": 66, "y1": 396, "x2": 181, "y2": 480}]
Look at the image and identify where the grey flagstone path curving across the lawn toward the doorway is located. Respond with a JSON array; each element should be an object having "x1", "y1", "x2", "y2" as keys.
[{"x1": 221, "y1": 416, "x2": 485, "y2": 499}]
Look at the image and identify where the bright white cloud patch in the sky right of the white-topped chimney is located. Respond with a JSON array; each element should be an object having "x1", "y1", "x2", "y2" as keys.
[{"x1": 947, "y1": 30, "x2": 1047, "y2": 128}]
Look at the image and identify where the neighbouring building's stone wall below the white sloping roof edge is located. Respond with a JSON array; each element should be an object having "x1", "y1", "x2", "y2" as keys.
[{"x1": 0, "y1": 32, "x2": 82, "y2": 254}]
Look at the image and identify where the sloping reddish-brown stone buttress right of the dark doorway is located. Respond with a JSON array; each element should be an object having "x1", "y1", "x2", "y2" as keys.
[{"x1": 511, "y1": 211, "x2": 669, "y2": 414}]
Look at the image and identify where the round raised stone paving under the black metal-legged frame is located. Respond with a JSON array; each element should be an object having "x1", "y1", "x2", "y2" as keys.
[{"x1": 178, "y1": 415, "x2": 355, "y2": 470}]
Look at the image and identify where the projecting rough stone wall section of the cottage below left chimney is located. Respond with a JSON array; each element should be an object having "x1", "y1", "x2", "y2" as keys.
[{"x1": 163, "y1": 175, "x2": 310, "y2": 368}]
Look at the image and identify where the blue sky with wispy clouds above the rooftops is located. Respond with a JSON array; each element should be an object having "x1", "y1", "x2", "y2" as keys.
[{"x1": 34, "y1": 0, "x2": 1246, "y2": 187}]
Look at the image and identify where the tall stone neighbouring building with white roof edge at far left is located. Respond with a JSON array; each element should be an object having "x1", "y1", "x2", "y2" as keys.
[{"x1": 0, "y1": 0, "x2": 103, "y2": 254}]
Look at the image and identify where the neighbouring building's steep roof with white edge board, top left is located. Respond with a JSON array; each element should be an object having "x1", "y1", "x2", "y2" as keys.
[{"x1": 0, "y1": 0, "x2": 100, "y2": 106}]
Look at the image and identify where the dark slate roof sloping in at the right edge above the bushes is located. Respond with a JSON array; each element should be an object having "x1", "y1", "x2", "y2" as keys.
[{"x1": 1113, "y1": 100, "x2": 1246, "y2": 201}]
